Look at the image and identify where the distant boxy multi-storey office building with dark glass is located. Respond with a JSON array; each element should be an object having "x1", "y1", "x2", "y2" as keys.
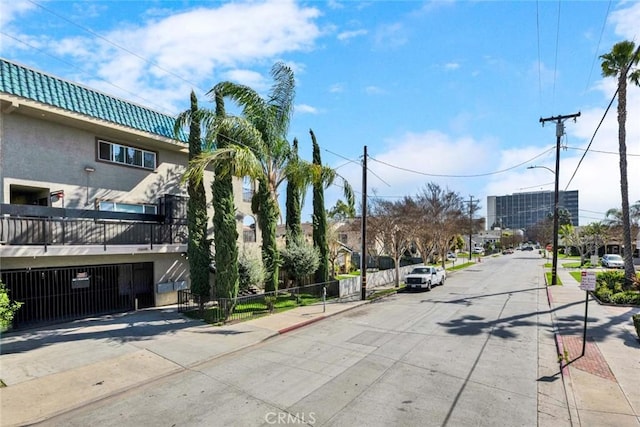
[{"x1": 487, "y1": 190, "x2": 579, "y2": 230}]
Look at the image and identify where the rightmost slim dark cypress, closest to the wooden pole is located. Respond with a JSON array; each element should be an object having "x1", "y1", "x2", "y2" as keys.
[{"x1": 309, "y1": 130, "x2": 329, "y2": 283}]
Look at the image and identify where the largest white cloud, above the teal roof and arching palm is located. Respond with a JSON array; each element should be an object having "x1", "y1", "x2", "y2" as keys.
[{"x1": 25, "y1": 0, "x2": 321, "y2": 112}]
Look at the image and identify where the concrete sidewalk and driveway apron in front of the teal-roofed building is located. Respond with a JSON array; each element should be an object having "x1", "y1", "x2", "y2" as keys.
[{"x1": 0, "y1": 300, "x2": 370, "y2": 426}]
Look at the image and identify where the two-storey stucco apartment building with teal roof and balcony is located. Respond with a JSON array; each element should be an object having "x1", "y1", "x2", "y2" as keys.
[{"x1": 0, "y1": 59, "x2": 260, "y2": 327}]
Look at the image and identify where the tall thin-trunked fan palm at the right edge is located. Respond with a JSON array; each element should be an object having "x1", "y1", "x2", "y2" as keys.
[{"x1": 600, "y1": 41, "x2": 640, "y2": 289}]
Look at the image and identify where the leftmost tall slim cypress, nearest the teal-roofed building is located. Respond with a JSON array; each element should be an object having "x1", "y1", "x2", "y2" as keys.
[{"x1": 174, "y1": 91, "x2": 211, "y2": 312}]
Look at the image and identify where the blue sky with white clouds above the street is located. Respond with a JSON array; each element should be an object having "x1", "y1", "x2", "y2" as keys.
[{"x1": 0, "y1": 0, "x2": 640, "y2": 225}]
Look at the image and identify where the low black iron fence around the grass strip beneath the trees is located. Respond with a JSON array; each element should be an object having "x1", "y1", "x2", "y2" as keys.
[{"x1": 178, "y1": 281, "x2": 340, "y2": 323}]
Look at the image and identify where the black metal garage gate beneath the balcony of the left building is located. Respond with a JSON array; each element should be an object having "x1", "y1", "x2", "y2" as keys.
[{"x1": 0, "y1": 262, "x2": 154, "y2": 329}]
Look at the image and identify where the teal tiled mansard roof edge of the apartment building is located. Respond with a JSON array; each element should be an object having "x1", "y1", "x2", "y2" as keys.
[{"x1": 0, "y1": 58, "x2": 183, "y2": 139}]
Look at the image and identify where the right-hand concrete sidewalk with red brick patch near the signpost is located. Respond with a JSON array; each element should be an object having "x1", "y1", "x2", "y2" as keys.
[{"x1": 547, "y1": 268, "x2": 640, "y2": 427}]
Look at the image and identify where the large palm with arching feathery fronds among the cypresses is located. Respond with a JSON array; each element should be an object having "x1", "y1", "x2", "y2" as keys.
[{"x1": 184, "y1": 62, "x2": 295, "y2": 291}]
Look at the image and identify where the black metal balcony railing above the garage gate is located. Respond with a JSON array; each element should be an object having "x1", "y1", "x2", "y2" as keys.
[{"x1": 0, "y1": 204, "x2": 188, "y2": 250}]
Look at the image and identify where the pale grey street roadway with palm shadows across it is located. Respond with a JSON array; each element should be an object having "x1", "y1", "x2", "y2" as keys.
[{"x1": 42, "y1": 253, "x2": 550, "y2": 426}]
